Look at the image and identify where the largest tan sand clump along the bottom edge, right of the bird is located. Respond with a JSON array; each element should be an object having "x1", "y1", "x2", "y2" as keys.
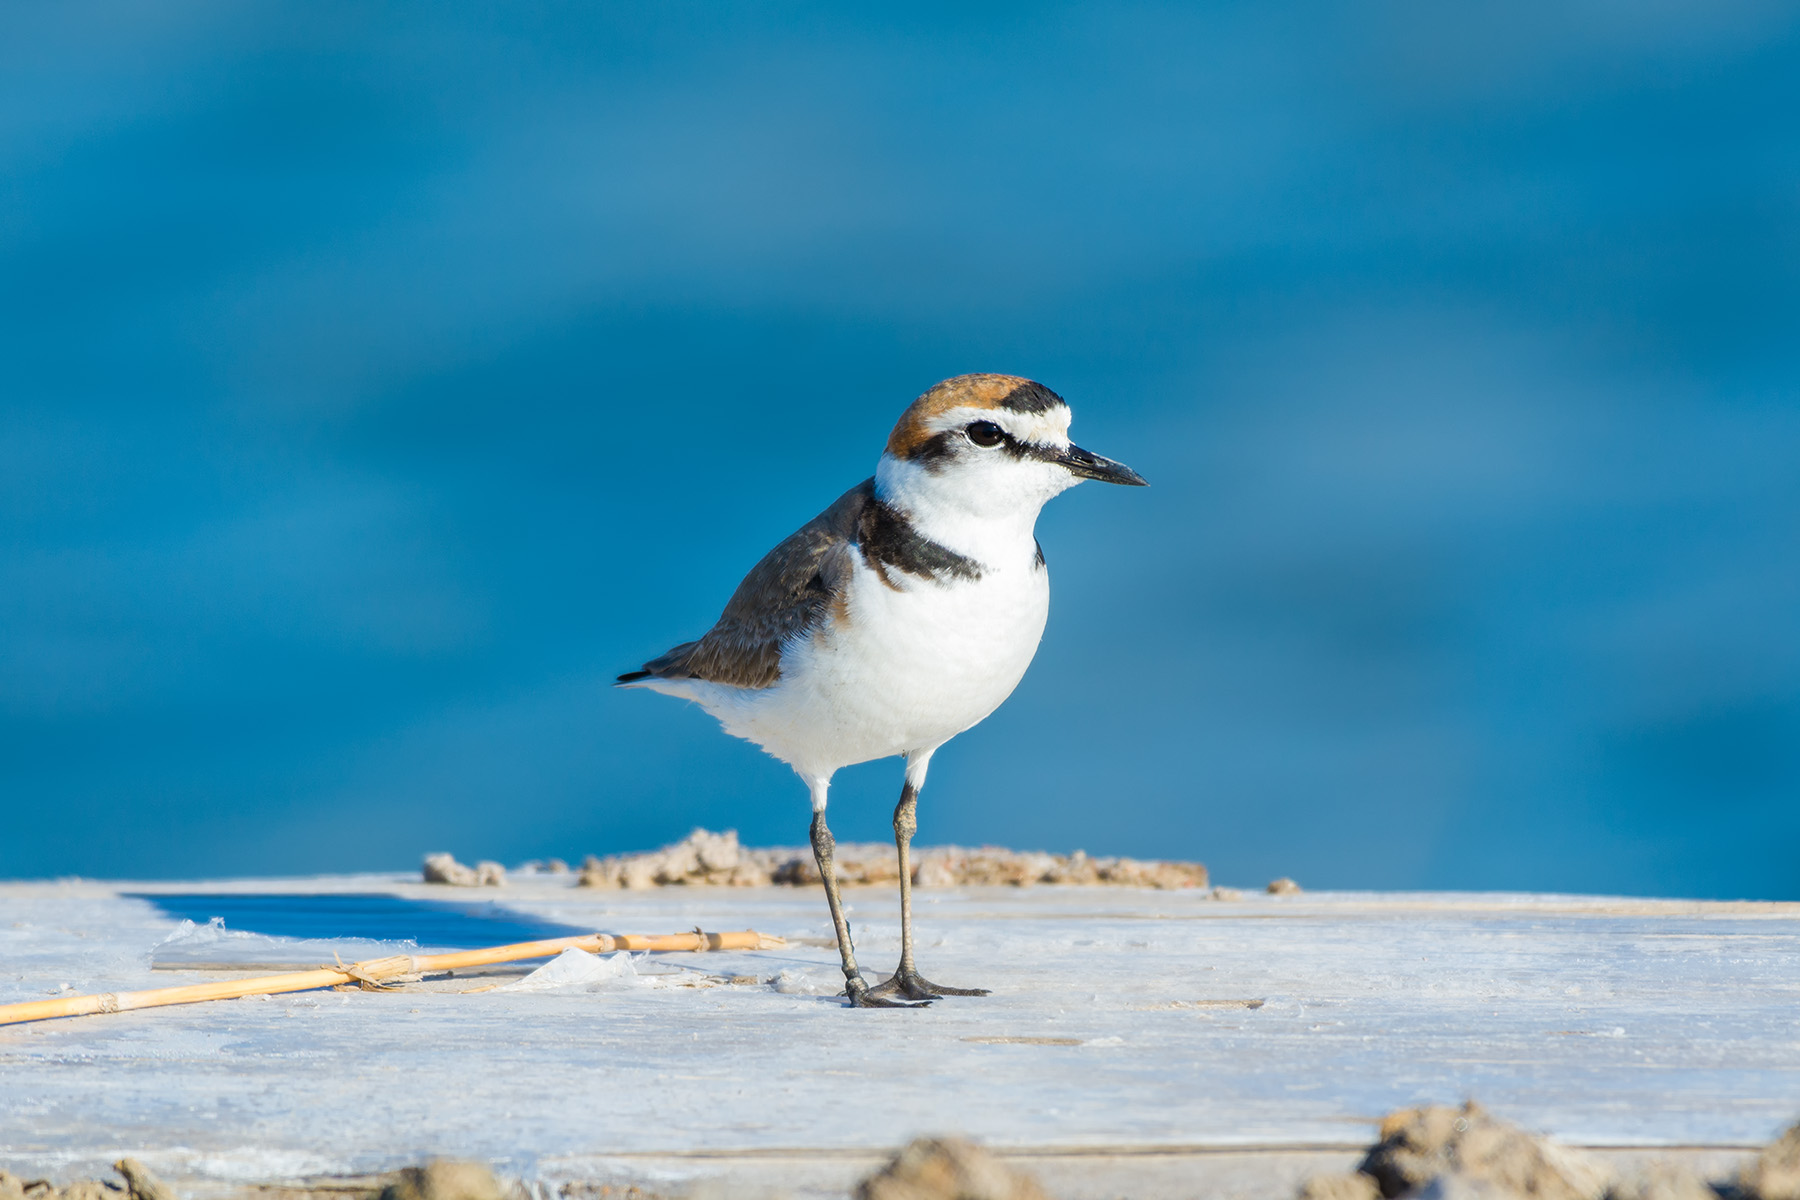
[{"x1": 1361, "y1": 1101, "x2": 1611, "y2": 1200}]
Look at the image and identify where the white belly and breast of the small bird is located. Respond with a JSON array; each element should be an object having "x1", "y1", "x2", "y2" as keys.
[{"x1": 684, "y1": 558, "x2": 1049, "y2": 775}]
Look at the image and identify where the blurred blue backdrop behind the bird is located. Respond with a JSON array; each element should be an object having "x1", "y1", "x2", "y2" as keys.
[{"x1": 0, "y1": 0, "x2": 1800, "y2": 898}]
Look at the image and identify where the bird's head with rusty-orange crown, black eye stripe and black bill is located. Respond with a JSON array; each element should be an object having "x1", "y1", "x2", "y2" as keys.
[{"x1": 875, "y1": 374, "x2": 1145, "y2": 516}]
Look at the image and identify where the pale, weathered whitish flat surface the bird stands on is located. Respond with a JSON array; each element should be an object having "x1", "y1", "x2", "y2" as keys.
[{"x1": 0, "y1": 876, "x2": 1800, "y2": 1198}]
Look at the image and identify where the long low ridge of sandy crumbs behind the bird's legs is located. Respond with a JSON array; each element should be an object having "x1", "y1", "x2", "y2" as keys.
[{"x1": 561, "y1": 829, "x2": 1208, "y2": 889}]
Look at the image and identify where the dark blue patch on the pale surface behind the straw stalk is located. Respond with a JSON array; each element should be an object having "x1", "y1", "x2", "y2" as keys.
[{"x1": 130, "y1": 892, "x2": 594, "y2": 950}]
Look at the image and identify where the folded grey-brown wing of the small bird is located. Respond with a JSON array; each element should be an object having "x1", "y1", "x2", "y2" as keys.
[{"x1": 619, "y1": 479, "x2": 875, "y2": 687}]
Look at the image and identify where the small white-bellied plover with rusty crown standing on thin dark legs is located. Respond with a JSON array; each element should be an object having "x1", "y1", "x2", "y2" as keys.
[{"x1": 619, "y1": 374, "x2": 1145, "y2": 1007}]
